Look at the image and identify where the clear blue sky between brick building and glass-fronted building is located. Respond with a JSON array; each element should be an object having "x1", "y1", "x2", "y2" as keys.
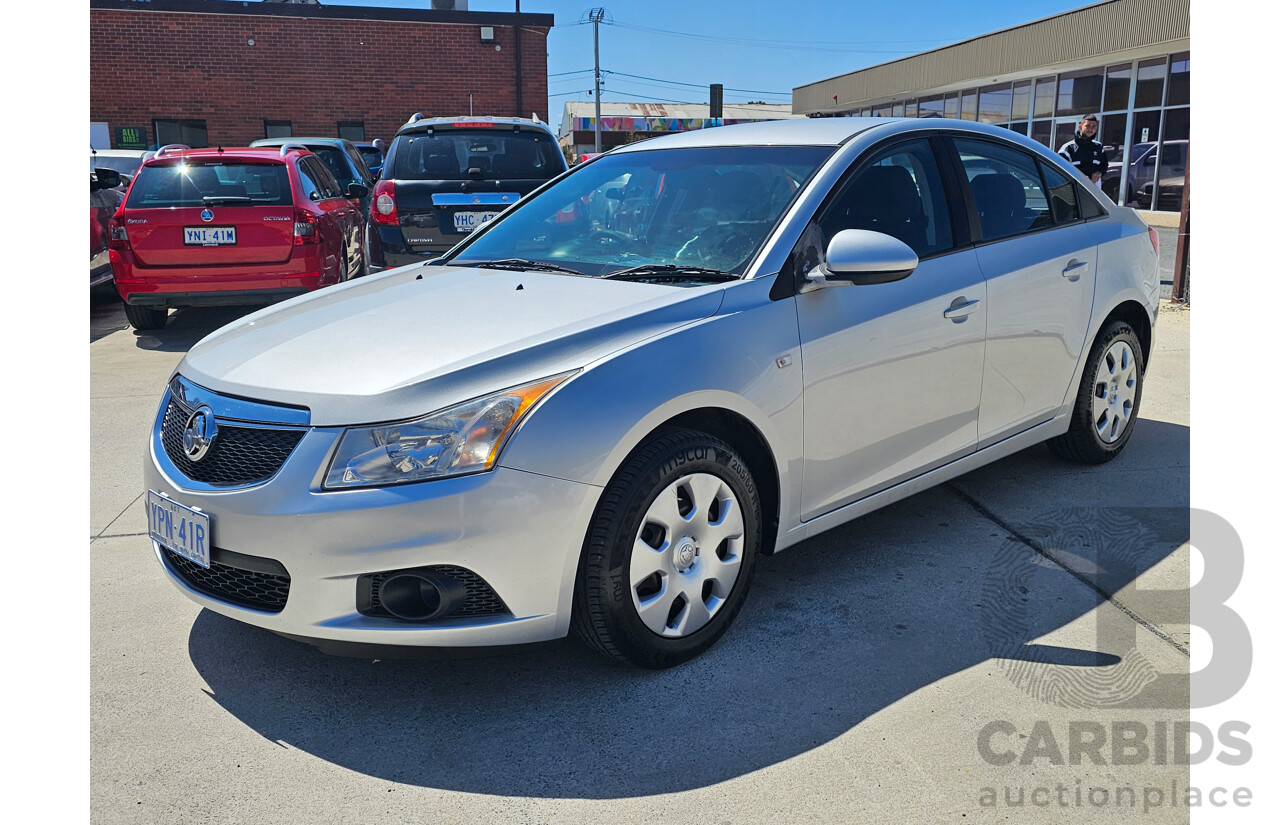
[{"x1": 332, "y1": 0, "x2": 1089, "y2": 117}]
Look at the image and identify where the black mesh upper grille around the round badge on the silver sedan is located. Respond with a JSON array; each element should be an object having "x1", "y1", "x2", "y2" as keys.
[{"x1": 160, "y1": 398, "x2": 306, "y2": 487}]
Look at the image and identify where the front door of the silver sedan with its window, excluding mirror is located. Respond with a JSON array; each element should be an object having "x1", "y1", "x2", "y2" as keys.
[{"x1": 794, "y1": 139, "x2": 987, "y2": 521}]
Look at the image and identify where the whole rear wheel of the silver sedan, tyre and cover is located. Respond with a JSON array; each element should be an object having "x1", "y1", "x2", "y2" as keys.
[{"x1": 1048, "y1": 321, "x2": 1144, "y2": 464}]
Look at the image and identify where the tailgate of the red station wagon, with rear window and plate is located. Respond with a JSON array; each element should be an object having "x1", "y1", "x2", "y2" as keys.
[{"x1": 124, "y1": 159, "x2": 293, "y2": 266}]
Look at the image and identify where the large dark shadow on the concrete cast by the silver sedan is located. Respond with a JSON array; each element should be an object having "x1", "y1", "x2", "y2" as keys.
[{"x1": 188, "y1": 422, "x2": 1189, "y2": 799}]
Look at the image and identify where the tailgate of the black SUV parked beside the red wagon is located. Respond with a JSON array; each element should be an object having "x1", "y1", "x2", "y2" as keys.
[{"x1": 383, "y1": 124, "x2": 566, "y2": 252}]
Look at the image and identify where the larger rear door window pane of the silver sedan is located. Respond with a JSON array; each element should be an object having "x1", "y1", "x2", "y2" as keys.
[{"x1": 955, "y1": 139, "x2": 1053, "y2": 240}]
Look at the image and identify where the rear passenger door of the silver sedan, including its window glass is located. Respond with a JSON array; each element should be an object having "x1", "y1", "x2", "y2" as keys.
[{"x1": 954, "y1": 137, "x2": 1098, "y2": 446}]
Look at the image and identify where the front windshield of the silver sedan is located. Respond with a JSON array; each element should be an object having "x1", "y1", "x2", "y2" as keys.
[{"x1": 448, "y1": 146, "x2": 835, "y2": 275}]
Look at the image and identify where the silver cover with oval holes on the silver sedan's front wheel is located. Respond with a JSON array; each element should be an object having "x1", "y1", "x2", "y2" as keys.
[{"x1": 630, "y1": 473, "x2": 744, "y2": 638}]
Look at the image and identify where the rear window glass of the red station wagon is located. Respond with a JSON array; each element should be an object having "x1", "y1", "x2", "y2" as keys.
[{"x1": 125, "y1": 161, "x2": 293, "y2": 208}]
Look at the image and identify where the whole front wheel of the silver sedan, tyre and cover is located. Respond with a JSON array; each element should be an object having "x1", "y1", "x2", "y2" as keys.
[{"x1": 573, "y1": 430, "x2": 762, "y2": 668}]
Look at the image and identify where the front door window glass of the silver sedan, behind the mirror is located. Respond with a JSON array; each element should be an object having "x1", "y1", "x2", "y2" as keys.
[{"x1": 818, "y1": 141, "x2": 952, "y2": 257}]
